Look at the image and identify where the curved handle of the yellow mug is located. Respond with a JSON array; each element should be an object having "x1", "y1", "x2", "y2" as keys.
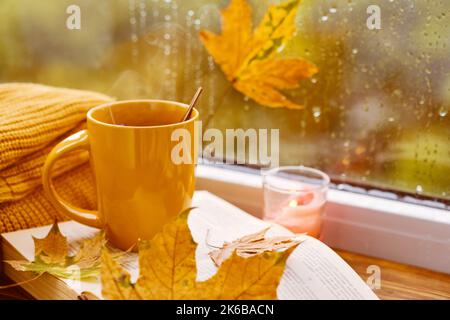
[{"x1": 42, "y1": 130, "x2": 102, "y2": 229}]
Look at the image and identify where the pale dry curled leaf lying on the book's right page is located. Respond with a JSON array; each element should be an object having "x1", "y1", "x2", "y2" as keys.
[{"x1": 209, "y1": 227, "x2": 302, "y2": 267}]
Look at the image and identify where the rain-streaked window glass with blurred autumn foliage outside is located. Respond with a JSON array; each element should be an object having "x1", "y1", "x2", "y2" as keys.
[{"x1": 0, "y1": 0, "x2": 450, "y2": 201}]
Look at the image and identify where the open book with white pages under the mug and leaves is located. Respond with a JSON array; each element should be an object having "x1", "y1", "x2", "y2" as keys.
[{"x1": 1, "y1": 191, "x2": 378, "y2": 299}]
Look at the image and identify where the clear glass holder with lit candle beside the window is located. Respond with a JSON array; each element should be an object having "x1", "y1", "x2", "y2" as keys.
[{"x1": 262, "y1": 166, "x2": 330, "y2": 238}]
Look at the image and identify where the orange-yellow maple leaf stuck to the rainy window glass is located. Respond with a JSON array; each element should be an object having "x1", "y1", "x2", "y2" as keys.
[{"x1": 200, "y1": 0, "x2": 318, "y2": 109}]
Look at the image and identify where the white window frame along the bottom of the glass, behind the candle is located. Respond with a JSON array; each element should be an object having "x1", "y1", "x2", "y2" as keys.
[{"x1": 196, "y1": 164, "x2": 450, "y2": 274}]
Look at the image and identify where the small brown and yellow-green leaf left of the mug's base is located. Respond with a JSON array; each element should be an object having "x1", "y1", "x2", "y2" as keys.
[{"x1": 5, "y1": 221, "x2": 105, "y2": 279}]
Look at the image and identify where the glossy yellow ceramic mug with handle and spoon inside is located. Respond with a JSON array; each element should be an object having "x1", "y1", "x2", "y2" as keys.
[{"x1": 43, "y1": 100, "x2": 198, "y2": 250}]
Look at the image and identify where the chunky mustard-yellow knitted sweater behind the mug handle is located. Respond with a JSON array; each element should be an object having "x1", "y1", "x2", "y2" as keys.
[{"x1": 0, "y1": 83, "x2": 112, "y2": 233}]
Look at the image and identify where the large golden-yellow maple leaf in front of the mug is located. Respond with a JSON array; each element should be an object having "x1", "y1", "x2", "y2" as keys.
[{"x1": 101, "y1": 210, "x2": 295, "y2": 300}]
